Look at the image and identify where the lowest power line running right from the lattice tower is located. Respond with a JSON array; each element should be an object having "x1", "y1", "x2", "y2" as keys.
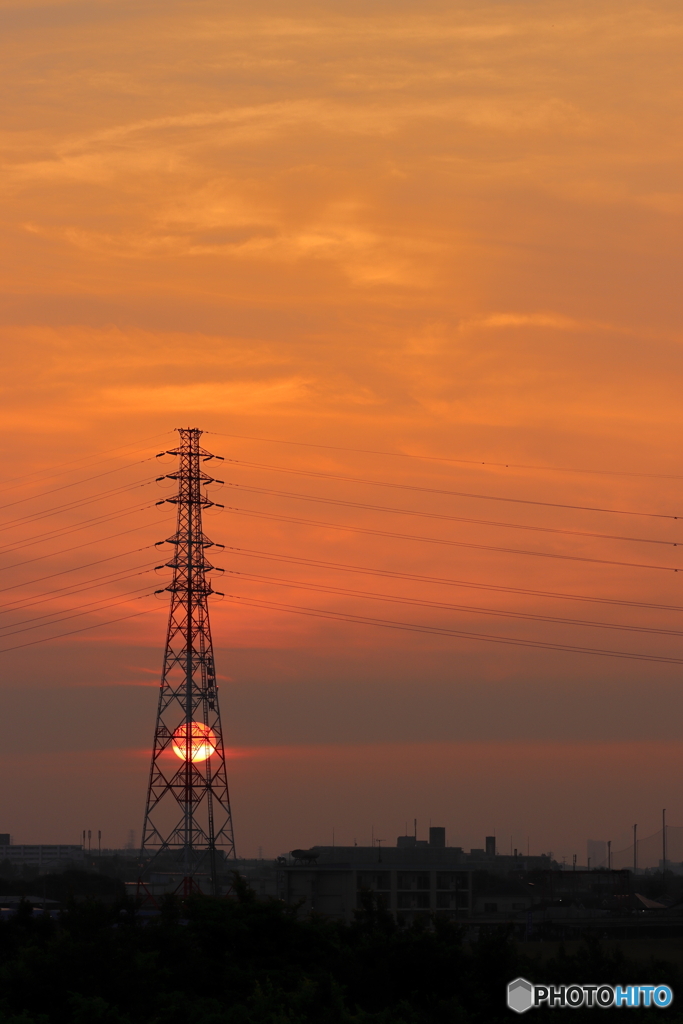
[{"x1": 225, "y1": 594, "x2": 683, "y2": 665}]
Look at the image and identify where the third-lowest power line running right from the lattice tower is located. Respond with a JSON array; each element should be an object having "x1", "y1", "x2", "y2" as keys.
[{"x1": 225, "y1": 546, "x2": 683, "y2": 611}]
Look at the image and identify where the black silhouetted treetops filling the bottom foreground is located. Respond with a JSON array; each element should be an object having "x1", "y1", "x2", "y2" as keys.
[{"x1": 0, "y1": 880, "x2": 683, "y2": 1024}]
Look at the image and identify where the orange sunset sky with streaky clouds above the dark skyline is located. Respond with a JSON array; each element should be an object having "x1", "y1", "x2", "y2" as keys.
[{"x1": 0, "y1": 0, "x2": 683, "y2": 860}]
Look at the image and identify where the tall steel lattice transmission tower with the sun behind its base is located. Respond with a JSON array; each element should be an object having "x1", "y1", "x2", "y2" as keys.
[{"x1": 140, "y1": 428, "x2": 236, "y2": 894}]
